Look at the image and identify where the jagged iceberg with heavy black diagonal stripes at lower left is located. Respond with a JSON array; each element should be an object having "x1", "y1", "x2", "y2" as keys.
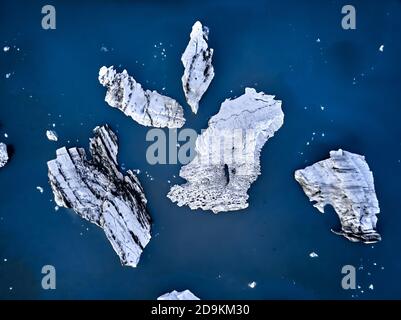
[{"x1": 47, "y1": 125, "x2": 151, "y2": 267}]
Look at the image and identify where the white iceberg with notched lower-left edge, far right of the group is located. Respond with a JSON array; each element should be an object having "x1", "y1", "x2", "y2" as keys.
[{"x1": 295, "y1": 149, "x2": 381, "y2": 243}]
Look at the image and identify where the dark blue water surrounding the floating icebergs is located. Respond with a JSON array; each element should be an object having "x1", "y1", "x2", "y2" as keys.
[{"x1": 0, "y1": 0, "x2": 401, "y2": 299}]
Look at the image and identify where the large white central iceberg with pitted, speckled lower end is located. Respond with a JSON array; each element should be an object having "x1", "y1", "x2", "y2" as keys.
[{"x1": 167, "y1": 88, "x2": 284, "y2": 213}]
